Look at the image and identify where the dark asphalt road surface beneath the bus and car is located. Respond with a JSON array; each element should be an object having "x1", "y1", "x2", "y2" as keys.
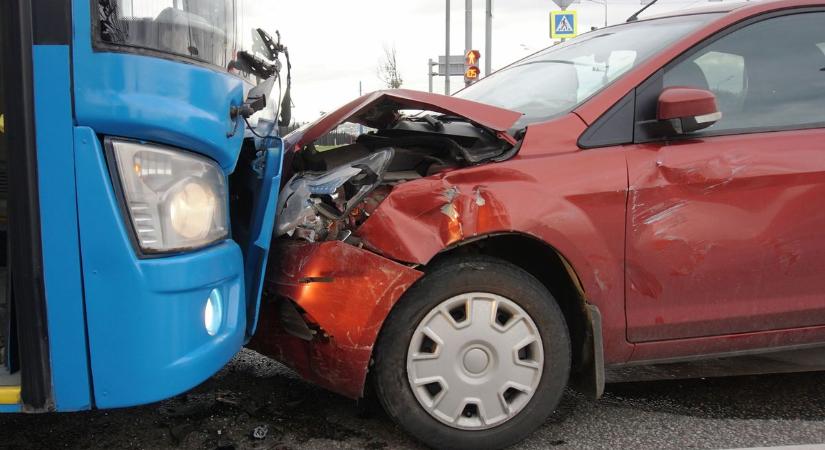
[{"x1": 0, "y1": 351, "x2": 825, "y2": 450}]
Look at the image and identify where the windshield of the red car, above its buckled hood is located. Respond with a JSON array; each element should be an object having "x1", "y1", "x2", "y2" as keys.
[{"x1": 455, "y1": 14, "x2": 718, "y2": 128}]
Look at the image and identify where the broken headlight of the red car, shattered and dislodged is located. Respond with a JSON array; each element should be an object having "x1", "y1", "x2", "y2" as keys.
[{"x1": 276, "y1": 148, "x2": 394, "y2": 240}]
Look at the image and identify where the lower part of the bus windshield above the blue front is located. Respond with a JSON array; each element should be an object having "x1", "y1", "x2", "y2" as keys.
[{"x1": 98, "y1": 0, "x2": 244, "y2": 68}]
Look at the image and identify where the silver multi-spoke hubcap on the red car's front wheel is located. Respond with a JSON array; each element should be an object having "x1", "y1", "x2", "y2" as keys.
[{"x1": 407, "y1": 292, "x2": 544, "y2": 430}]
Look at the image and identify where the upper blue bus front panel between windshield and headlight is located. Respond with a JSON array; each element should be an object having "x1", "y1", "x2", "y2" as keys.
[{"x1": 72, "y1": 0, "x2": 244, "y2": 172}]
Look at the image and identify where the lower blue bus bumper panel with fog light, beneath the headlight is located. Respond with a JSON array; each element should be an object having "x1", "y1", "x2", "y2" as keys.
[{"x1": 75, "y1": 127, "x2": 246, "y2": 408}]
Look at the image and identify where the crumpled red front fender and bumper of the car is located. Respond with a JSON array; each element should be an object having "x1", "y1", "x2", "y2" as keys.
[{"x1": 266, "y1": 110, "x2": 632, "y2": 378}]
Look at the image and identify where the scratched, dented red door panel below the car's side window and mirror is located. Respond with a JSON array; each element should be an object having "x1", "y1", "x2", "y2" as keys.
[{"x1": 626, "y1": 131, "x2": 825, "y2": 342}]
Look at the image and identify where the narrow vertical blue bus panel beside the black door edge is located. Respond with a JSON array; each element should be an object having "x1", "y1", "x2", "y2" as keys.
[{"x1": 32, "y1": 45, "x2": 91, "y2": 411}]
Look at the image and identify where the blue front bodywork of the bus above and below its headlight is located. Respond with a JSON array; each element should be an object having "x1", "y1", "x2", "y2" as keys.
[{"x1": 67, "y1": 1, "x2": 260, "y2": 408}]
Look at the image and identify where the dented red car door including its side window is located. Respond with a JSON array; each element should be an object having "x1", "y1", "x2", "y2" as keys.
[{"x1": 626, "y1": 12, "x2": 825, "y2": 342}]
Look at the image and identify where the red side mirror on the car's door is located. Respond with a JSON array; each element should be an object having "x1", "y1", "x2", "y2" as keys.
[{"x1": 656, "y1": 87, "x2": 722, "y2": 134}]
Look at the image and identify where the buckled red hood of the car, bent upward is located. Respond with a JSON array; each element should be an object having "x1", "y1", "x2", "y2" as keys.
[{"x1": 284, "y1": 89, "x2": 522, "y2": 150}]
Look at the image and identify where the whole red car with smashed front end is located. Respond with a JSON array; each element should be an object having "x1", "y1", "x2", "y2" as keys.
[{"x1": 252, "y1": 0, "x2": 825, "y2": 448}]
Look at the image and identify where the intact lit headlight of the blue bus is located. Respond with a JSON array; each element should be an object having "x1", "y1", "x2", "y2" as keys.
[{"x1": 107, "y1": 139, "x2": 229, "y2": 253}]
